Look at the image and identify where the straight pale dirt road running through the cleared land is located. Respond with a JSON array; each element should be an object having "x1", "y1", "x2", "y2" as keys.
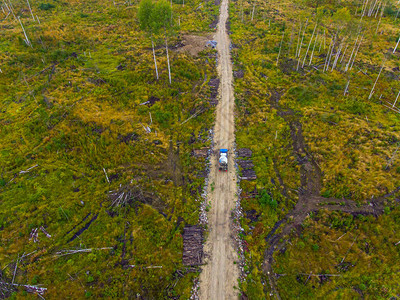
[{"x1": 200, "y1": 0, "x2": 239, "y2": 300}]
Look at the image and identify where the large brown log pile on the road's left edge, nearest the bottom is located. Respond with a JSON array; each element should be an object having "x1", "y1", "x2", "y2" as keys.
[{"x1": 182, "y1": 225, "x2": 203, "y2": 266}]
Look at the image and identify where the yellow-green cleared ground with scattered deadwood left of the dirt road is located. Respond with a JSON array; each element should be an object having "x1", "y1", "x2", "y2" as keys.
[{"x1": 0, "y1": 0, "x2": 218, "y2": 299}]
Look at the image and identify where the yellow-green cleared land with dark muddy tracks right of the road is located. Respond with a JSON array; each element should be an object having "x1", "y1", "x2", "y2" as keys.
[{"x1": 230, "y1": 0, "x2": 400, "y2": 299}]
